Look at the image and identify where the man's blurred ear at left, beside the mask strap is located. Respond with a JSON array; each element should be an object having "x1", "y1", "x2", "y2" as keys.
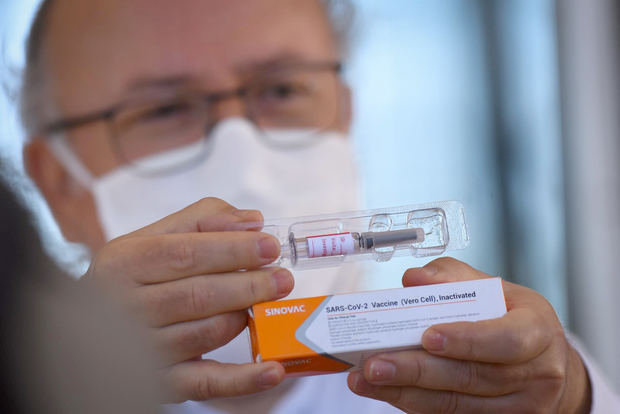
[{"x1": 23, "y1": 138, "x2": 103, "y2": 248}]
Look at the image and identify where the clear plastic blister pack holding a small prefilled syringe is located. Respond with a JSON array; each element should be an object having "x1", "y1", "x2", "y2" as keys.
[{"x1": 254, "y1": 201, "x2": 469, "y2": 269}]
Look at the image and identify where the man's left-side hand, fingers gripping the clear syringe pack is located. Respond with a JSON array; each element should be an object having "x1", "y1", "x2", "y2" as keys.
[{"x1": 85, "y1": 198, "x2": 294, "y2": 402}]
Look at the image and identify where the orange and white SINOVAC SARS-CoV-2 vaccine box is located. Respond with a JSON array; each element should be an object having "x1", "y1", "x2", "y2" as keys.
[{"x1": 249, "y1": 277, "x2": 506, "y2": 376}]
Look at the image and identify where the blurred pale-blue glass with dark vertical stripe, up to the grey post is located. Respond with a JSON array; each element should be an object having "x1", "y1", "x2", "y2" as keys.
[{"x1": 348, "y1": 0, "x2": 568, "y2": 322}]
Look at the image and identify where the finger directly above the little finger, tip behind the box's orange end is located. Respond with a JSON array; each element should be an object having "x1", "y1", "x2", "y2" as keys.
[{"x1": 153, "y1": 311, "x2": 247, "y2": 365}]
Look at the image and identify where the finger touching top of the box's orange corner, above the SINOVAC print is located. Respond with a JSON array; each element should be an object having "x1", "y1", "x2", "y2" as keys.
[{"x1": 136, "y1": 267, "x2": 295, "y2": 326}]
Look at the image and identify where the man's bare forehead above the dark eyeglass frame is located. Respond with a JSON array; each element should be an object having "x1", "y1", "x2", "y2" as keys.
[{"x1": 47, "y1": 0, "x2": 337, "y2": 110}]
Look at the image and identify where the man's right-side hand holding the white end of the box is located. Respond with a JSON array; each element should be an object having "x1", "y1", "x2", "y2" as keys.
[{"x1": 348, "y1": 258, "x2": 590, "y2": 414}]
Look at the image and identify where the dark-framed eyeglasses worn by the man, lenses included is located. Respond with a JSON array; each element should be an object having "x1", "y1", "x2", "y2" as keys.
[{"x1": 44, "y1": 62, "x2": 342, "y2": 174}]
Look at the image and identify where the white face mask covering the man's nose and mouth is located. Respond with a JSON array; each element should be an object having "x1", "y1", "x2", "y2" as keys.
[{"x1": 51, "y1": 118, "x2": 362, "y2": 362}]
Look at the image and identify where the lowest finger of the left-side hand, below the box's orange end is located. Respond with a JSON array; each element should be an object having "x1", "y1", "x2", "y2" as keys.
[{"x1": 164, "y1": 360, "x2": 284, "y2": 402}]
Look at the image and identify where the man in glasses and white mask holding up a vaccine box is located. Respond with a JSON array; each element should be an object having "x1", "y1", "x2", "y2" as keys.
[{"x1": 18, "y1": 0, "x2": 616, "y2": 413}]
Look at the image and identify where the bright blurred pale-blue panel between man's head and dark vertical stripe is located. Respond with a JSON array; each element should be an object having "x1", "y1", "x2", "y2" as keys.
[{"x1": 347, "y1": 0, "x2": 506, "y2": 298}]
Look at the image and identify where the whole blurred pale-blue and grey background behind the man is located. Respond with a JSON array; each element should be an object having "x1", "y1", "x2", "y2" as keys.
[{"x1": 0, "y1": 0, "x2": 620, "y2": 390}]
